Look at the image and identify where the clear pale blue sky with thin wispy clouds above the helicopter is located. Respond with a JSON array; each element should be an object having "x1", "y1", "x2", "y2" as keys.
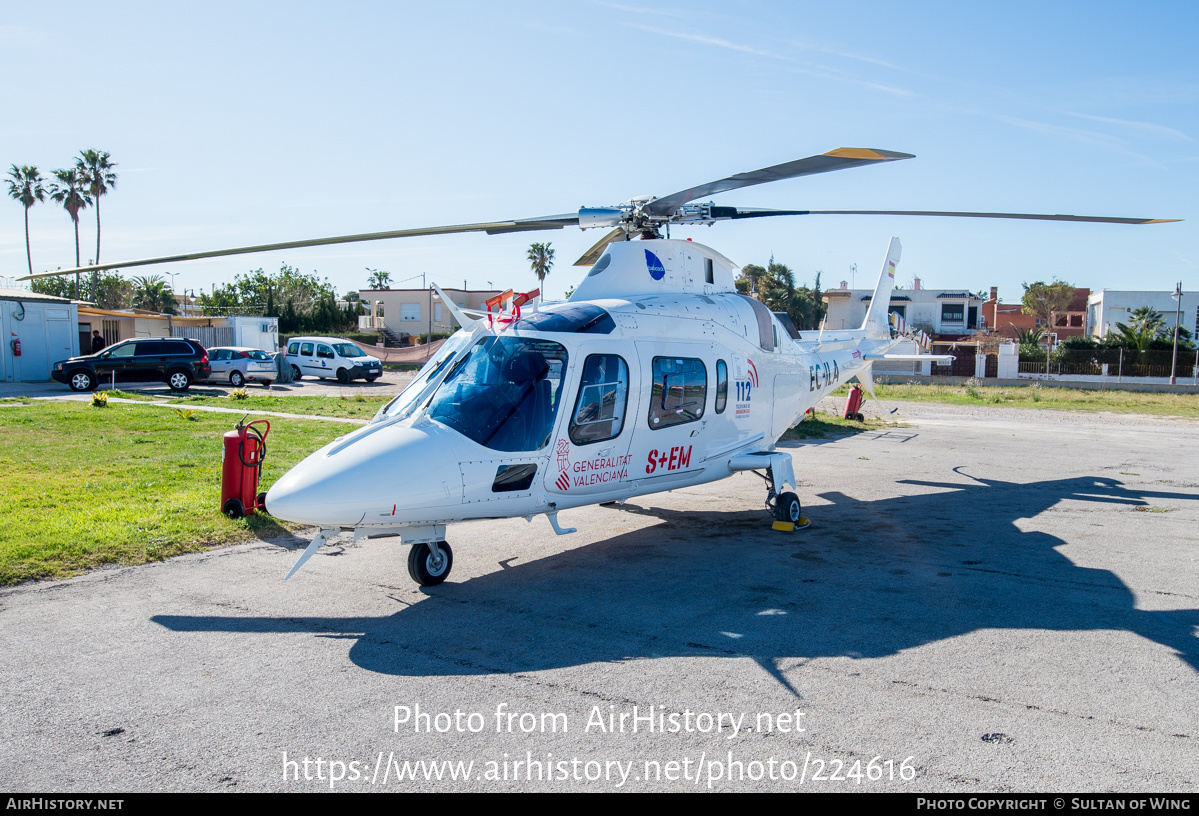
[{"x1": 0, "y1": 1, "x2": 1199, "y2": 302}]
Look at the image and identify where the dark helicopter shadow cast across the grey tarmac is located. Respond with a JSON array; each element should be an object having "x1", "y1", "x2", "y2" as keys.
[{"x1": 153, "y1": 467, "x2": 1199, "y2": 691}]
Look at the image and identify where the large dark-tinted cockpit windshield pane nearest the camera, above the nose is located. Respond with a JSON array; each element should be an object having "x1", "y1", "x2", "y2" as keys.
[{"x1": 428, "y1": 336, "x2": 566, "y2": 451}]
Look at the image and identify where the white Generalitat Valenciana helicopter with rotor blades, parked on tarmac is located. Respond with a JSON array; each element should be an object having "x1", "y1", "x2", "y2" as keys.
[{"x1": 29, "y1": 147, "x2": 1175, "y2": 586}]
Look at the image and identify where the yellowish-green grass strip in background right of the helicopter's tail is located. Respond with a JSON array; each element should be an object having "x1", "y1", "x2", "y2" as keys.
[{"x1": 832, "y1": 382, "x2": 1199, "y2": 419}]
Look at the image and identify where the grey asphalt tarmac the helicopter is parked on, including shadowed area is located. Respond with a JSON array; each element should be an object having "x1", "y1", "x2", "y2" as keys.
[{"x1": 0, "y1": 404, "x2": 1199, "y2": 793}]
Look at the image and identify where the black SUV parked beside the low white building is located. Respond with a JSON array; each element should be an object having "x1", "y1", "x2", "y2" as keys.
[{"x1": 50, "y1": 337, "x2": 211, "y2": 391}]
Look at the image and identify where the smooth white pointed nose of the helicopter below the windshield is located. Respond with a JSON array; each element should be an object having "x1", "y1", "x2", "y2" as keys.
[{"x1": 266, "y1": 425, "x2": 462, "y2": 527}]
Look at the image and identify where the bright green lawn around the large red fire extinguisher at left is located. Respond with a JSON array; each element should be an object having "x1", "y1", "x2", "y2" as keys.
[{"x1": 0, "y1": 400, "x2": 349, "y2": 585}]
